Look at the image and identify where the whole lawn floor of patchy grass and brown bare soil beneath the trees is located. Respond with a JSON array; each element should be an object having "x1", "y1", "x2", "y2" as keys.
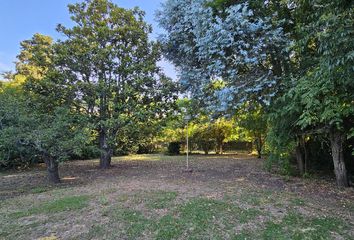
[{"x1": 0, "y1": 154, "x2": 354, "y2": 240}]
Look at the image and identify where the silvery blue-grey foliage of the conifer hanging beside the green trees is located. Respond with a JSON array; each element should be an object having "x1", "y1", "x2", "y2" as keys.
[{"x1": 158, "y1": 0, "x2": 287, "y2": 110}]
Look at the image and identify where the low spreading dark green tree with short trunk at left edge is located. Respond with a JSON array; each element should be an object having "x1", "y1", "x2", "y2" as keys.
[{"x1": 0, "y1": 78, "x2": 90, "y2": 183}]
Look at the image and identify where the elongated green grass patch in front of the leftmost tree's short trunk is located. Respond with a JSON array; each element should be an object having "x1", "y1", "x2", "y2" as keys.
[{"x1": 10, "y1": 196, "x2": 89, "y2": 218}]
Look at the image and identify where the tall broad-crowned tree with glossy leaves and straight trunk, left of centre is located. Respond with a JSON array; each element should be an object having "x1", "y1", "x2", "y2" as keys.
[{"x1": 55, "y1": 0, "x2": 173, "y2": 168}]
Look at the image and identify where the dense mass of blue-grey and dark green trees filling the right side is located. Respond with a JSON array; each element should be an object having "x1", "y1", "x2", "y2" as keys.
[{"x1": 158, "y1": 0, "x2": 354, "y2": 187}]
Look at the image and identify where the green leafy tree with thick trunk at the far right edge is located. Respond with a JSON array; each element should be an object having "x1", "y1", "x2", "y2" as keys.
[{"x1": 290, "y1": 0, "x2": 354, "y2": 187}]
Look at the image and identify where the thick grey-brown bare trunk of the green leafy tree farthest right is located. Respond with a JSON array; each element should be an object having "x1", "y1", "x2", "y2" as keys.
[{"x1": 330, "y1": 129, "x2": 349, "y2": 187}]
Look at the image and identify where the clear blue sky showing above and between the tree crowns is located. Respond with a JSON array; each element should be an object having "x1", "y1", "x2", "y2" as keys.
[{"x1": 0, "y1": 0, "x2": 176, "y2": 79}]
